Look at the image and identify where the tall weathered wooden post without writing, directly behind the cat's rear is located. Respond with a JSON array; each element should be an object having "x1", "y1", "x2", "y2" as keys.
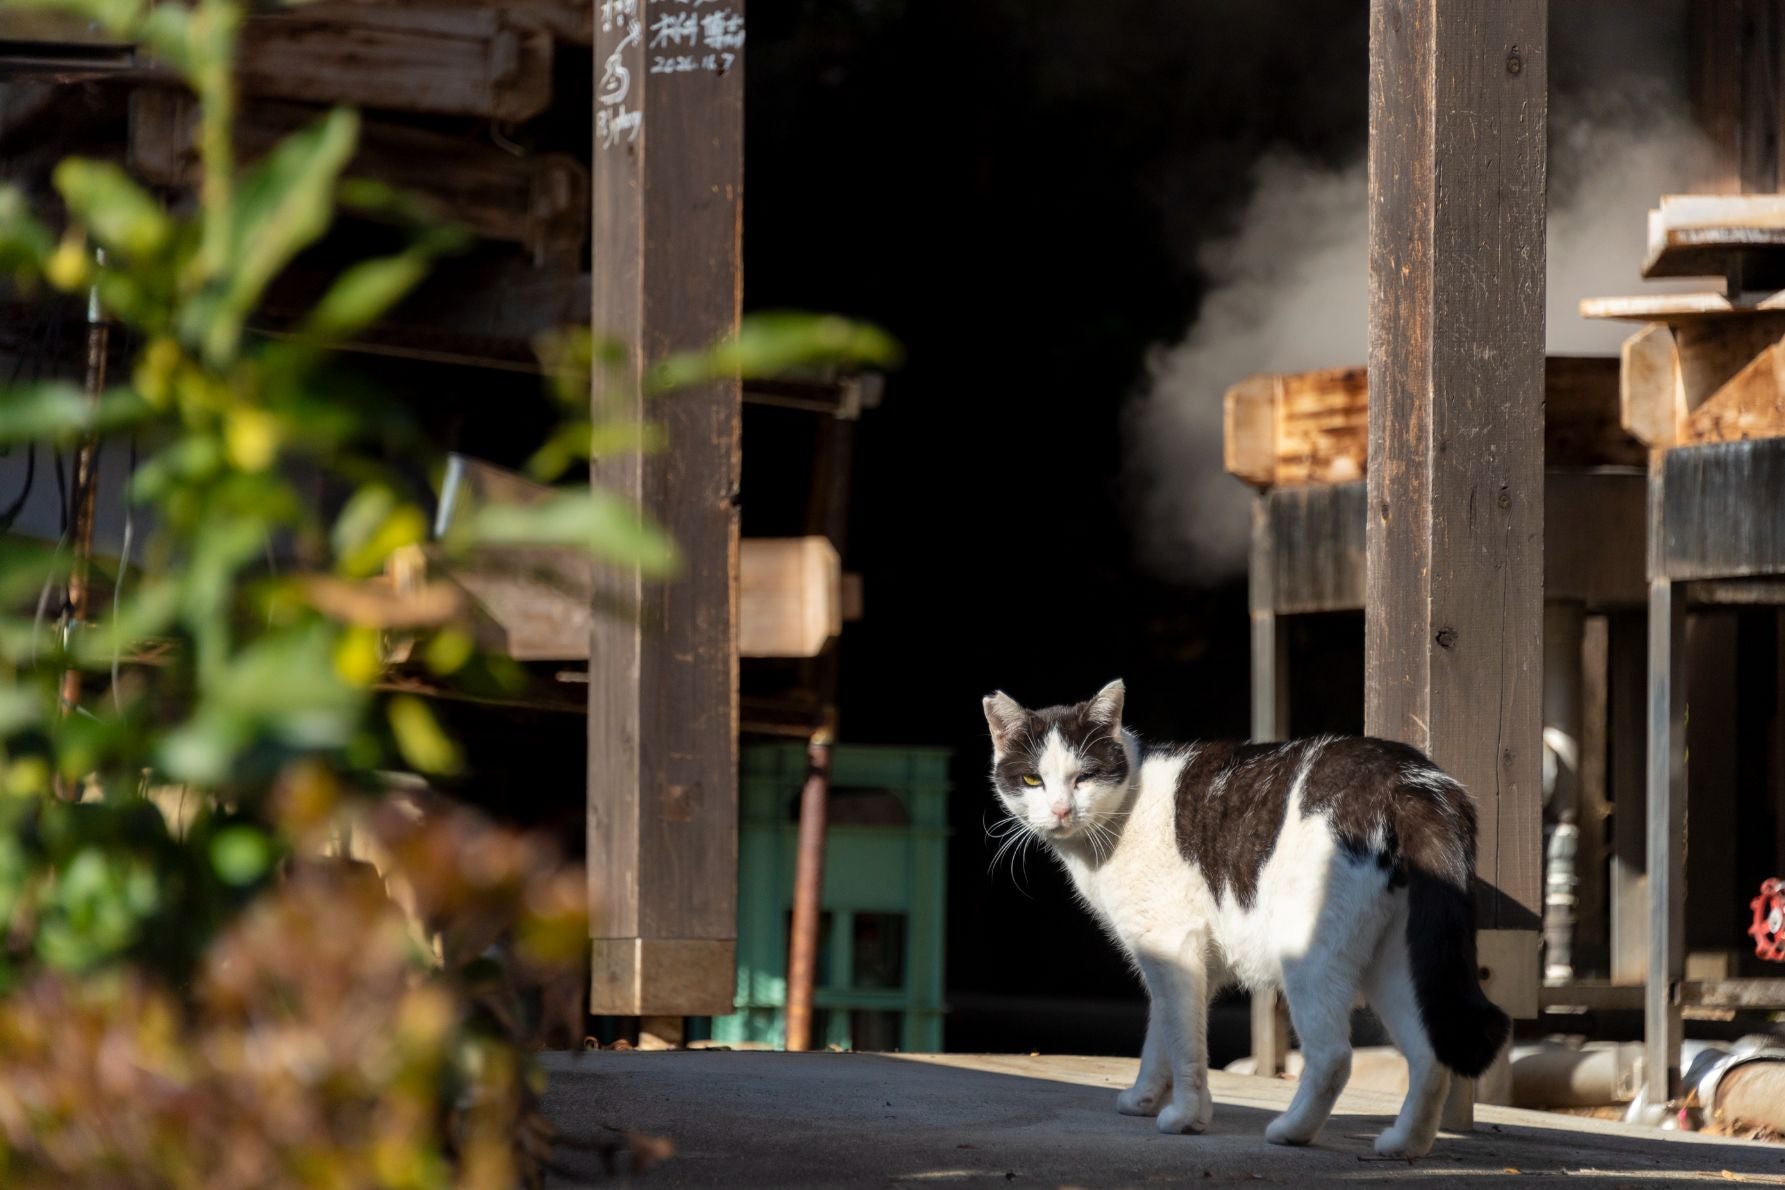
[{"x1": 1364, "y1": 0, "x2": 1548, "y2": 1126}]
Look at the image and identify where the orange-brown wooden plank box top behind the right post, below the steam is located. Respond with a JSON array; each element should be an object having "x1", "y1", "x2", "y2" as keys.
[{"x1": 1223, "y1": 355, "x2": 1642, "y2": 487}]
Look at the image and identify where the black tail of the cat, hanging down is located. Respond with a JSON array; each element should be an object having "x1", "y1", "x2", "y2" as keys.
[{"x1": 1396, "y1": 769, "x2": 1512, "y2": 1078}]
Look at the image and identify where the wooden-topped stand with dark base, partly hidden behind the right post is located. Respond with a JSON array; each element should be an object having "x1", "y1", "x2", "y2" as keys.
[{"x1": 1226, "y1": 357, "x2": 1648, "y2": 1091}]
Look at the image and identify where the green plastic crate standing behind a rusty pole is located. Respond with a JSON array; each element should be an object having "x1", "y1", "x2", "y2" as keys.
[{"x1": 712, "y1": 744, "x2": 950, "y2": 1053}]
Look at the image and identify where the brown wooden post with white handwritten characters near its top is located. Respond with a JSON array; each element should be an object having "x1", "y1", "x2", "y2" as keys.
[{"x1": 587, "y1": 0, "x2": 744, "y2": 1015}]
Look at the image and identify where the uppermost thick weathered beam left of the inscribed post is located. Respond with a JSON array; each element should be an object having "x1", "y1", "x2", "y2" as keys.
[{"x1": 236, "y1": 0, "x2": 552, "y2": 121}]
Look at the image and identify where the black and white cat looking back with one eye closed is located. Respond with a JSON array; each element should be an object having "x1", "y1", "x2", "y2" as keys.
[{"x1": 985, "y1": 682, "x2": 1512, "y2": 1156}]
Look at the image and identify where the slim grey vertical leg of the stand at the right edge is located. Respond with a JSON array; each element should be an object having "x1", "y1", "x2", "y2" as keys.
[{"x1": 1642, "y1": 578, "x2": 1687, "y2": 1115}]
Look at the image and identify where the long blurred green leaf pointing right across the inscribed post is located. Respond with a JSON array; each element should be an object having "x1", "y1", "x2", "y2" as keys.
[{"x1": 644, "y1": 314, "x2": 900, "y2": 393}]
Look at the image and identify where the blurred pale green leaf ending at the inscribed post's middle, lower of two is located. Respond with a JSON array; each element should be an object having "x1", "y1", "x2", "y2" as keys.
[{"x1": 455, "y1": 489, "x2": 677, "y2": 576}]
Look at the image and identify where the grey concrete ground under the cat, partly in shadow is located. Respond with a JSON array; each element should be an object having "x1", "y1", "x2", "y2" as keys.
[{"x1": 546, "y1": 1051, "x2": 1785, "y2": 1186}]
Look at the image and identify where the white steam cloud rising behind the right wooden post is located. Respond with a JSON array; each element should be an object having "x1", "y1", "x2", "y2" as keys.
[{"x1": 1126, "y1": 102, "x2": 1710, "y2": 583}]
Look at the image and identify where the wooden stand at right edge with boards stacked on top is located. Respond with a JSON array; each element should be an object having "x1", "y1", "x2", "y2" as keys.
[{"x1": 1582, "y1": 276, "x2": 1785, "y2": 1115}]
